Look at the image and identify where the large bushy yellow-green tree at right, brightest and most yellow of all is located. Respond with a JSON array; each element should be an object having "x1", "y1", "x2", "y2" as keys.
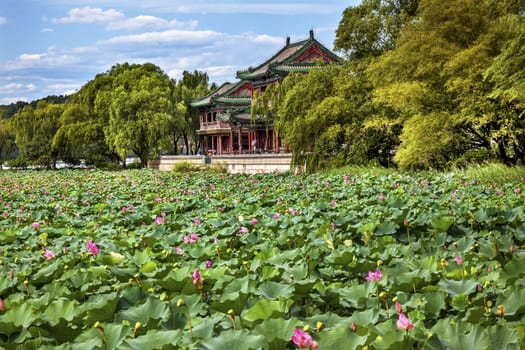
[{"x1": 368, "y1": 0, "x2": 523, "y2": 167}]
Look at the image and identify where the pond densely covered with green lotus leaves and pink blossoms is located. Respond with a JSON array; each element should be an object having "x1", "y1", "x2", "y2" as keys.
[{"x1": 0, "y1": 170, "x2": 525, "y2": 350}]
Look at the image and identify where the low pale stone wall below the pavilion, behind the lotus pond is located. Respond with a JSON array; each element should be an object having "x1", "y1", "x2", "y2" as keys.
[{"x1": 148, "y1": 153, "x2": 292, "y2": 174}]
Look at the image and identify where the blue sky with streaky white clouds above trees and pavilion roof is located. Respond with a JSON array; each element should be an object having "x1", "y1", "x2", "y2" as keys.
[{"x1": 0, "y1": 0, "x2": 361, "y2": 104}]
